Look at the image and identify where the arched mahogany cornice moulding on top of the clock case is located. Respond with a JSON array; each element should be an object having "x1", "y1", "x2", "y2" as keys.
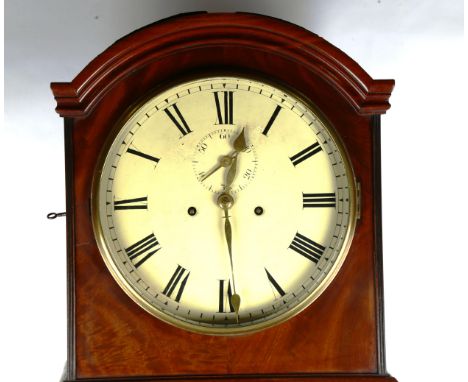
[{"x1": 51, "y1": 12, "x2": 394, "y2": 118}]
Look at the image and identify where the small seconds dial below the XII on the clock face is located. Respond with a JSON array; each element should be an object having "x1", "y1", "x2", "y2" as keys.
[{"x1": 192, "y1": 127, "x2": 258, "y2": 194}]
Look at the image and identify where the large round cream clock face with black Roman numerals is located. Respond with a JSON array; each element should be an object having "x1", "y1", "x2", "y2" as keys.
[{"x1": 93, "y1": 77, "x2": 355, "y2": 334}]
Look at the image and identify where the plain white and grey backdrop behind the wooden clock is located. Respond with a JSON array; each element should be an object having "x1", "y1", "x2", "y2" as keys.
[{"x1": 0, "y1": 0, "x2": 468, "y2": 382}]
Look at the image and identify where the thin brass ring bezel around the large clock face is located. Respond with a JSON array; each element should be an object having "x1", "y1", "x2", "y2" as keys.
[{"x1": 91, "y1": 70, "x2": 357, "y2": 336}]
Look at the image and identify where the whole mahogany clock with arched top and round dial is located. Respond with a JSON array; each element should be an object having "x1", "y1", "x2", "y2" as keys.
[{"x1": 52, "y1": 13, "x2": 395, "y2": 382}]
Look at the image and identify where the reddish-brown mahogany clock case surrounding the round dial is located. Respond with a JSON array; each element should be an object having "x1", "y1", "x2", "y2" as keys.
[{"x1": 51, "y1": 12, "x2": 395, "y2": 382}]
